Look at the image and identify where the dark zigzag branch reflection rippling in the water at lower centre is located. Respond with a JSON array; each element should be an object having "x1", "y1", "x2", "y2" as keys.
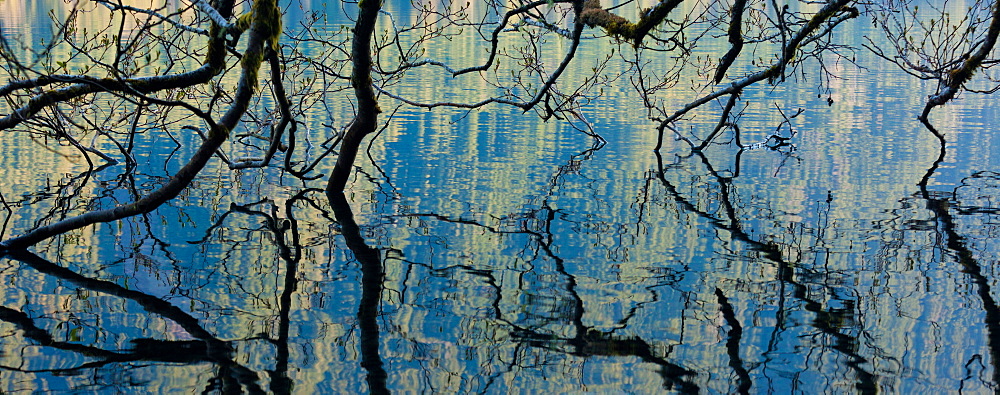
[{"x1": 382, "y1": 140, "x2": 700, "y2": 393}]
